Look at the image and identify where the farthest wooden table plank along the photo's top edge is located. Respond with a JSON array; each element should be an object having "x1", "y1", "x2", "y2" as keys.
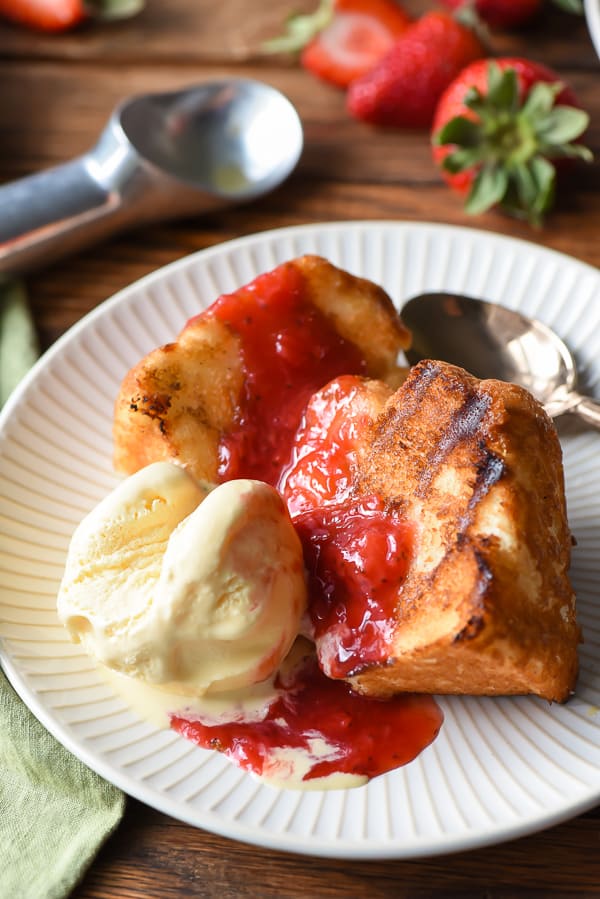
[{"x1": 0, "y1": 0, "x2": 597, "y2": 69}]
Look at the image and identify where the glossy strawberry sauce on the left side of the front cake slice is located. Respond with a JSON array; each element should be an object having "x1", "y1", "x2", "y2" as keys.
[{"x1": 279, "y1": 376, "x2": 413, "y2": 677}]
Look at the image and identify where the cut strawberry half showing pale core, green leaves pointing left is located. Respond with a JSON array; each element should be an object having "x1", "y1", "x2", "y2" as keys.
[{"x1": 264, "y1": 0, "x2": 411, "y2": 87}]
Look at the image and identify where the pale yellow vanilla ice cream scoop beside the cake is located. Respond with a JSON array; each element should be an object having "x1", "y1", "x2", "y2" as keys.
[{"x1": 58, "y1": 462, "x2": 306, "y2": 695}]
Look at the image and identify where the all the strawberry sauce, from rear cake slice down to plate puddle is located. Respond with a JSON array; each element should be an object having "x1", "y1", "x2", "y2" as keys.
[{"x1": 171, "y1": 276, "x2": 442, "y2": 786}]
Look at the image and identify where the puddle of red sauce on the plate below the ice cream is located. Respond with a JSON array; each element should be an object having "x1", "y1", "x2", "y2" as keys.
[{"x1": 171, "y1": 655, "x2": 442, "y2": 781}]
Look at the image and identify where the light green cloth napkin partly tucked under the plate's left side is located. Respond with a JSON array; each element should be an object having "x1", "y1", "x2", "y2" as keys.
[{"x1": 0, "y1": 282, "x2": 125, "y2": 899}]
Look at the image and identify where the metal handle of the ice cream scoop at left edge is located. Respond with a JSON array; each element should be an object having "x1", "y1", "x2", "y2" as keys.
[{"x1": 0, "y1": 156, "x2": 121, "y2": 274}]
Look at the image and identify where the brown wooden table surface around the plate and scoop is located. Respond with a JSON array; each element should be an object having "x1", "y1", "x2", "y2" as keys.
[{"x1": 0, "y1": 0, "x2": 600, "y2": 899}]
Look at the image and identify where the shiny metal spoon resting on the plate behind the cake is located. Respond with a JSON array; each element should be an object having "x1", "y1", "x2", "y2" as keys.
[{"x1": 401, "y1": 293, "x2": 600, "y2": 428}]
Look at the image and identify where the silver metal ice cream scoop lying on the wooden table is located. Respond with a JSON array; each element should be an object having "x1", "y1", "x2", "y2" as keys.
[{"x1": 0, "y1": 79, "x2": 303, "y2": 273}]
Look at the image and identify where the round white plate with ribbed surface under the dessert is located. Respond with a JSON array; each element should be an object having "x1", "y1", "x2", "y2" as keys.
[{"x1": 0, "y1": 222, "x2": 600, "y2": 858}]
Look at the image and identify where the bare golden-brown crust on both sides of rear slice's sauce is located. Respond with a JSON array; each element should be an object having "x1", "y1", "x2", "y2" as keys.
[{"x1": 113, "y1": 256, "x2": 410, "y2": 481}]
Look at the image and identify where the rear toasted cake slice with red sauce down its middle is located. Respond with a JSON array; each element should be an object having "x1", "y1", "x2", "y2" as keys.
[{"x1": 114, "y1": 256, "x2": 410, "y2": 481}]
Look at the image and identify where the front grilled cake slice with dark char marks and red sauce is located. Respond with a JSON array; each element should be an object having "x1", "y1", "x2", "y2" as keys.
[{"x1": 281, "y1": 361, "x2": 580, "y2": 701}]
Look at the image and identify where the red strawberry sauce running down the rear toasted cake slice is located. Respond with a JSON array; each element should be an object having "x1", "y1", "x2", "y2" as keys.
[{"x1": 207, "y1": 264, "x2": 366, "y2": 484}]
